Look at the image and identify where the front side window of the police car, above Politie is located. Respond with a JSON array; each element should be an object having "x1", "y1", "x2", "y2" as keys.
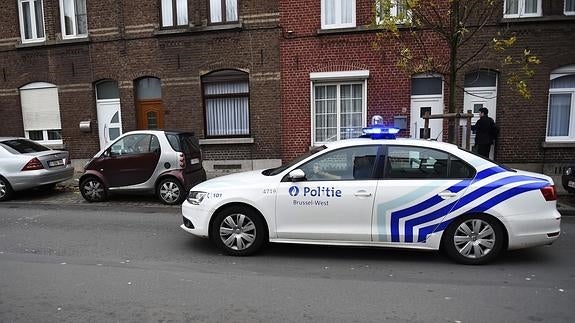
[{"x1": 300, "y1": 145, "x2": 379, "y2": 181}]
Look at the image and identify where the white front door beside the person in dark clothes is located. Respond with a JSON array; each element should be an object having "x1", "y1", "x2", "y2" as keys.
[{"x1": 462, "y1": 87, "x2": 497, "y2": 159}]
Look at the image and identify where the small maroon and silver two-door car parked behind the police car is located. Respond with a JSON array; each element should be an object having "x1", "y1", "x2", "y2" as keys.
[{"x1": 79, "y1": 130, "x2": 206, "y2": 204}]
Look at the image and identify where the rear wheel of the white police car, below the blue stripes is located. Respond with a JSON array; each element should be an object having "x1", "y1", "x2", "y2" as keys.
[{"x1": 443, "y1": 215, "x2": 504, "y2": 265}]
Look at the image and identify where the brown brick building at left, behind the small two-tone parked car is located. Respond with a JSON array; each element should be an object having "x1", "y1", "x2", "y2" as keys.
[{"x1": 0, "y1": 0, "x2": 281, "y2": 176}]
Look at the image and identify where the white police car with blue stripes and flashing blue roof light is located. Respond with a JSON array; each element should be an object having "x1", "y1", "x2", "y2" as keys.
[{"x1": 181, "y1": 127, "x2": 561, "y2": 264}]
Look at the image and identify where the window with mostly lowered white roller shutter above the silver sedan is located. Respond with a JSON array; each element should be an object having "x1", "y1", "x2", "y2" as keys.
[{"x1": 20, "y1": 82, "x2": 62, "y2": 144}]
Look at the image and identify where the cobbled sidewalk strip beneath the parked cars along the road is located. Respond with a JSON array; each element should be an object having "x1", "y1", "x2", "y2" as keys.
[{"x1": 4, "y1": 175, "x2": 575, "y2": 216}]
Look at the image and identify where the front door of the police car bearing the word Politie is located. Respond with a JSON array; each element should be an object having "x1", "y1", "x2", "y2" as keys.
[{"x1": 276, "y1": 145, "x2": 379, "y2": 242}]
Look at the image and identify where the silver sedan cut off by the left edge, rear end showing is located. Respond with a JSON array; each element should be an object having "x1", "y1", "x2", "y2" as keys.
[{"x1": 0, "y1": 137, "x2": 74, "y2": 201}]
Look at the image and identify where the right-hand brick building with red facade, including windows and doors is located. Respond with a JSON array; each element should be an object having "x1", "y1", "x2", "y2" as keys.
[{"x1": 280, "y1": 0, "x2": 575, "y2": 190}]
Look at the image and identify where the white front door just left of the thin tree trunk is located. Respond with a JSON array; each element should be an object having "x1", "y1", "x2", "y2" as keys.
[{"x1": 410, "y1": 96, "x2": 443, "y2": 141}]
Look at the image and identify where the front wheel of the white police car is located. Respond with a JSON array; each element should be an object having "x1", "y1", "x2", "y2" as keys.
[{"x1": 210, "y1": 206, "x2": 265, "y2": 256}]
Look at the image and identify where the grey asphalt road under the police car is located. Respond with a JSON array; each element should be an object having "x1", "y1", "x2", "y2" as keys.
[{"x1": 0, "y1": 203, "x2": 575, "y2": 322}]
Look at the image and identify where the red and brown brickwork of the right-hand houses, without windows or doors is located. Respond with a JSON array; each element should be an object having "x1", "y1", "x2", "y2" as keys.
[{"x1": 280, "y1": 0, "x2": 575, "y2": 180}]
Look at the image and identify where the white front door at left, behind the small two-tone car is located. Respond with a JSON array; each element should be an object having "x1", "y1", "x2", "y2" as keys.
[{"x1": 97, "y1": 99, "x2": 122, "y2": 149}]
